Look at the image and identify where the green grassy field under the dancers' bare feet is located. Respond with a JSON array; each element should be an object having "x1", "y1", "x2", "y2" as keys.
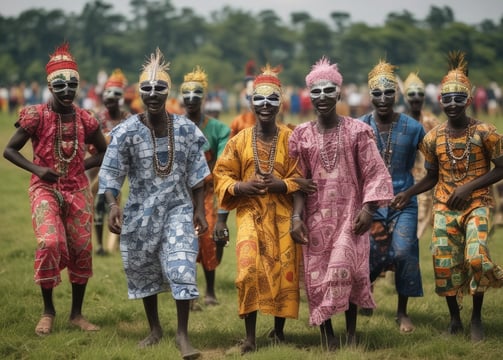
[{"x1": 0, "y1": 110, "x2": 503, "y2": 360}]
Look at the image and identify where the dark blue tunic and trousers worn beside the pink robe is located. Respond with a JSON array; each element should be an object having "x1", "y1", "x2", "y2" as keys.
[{"x1": 360, "y1": 113, "x2": 425, "y2": 297}]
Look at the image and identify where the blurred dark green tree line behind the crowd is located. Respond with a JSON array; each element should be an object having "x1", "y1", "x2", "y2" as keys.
[{"x1": 0, "y1": 0, "x2": 503, "y2": 88}]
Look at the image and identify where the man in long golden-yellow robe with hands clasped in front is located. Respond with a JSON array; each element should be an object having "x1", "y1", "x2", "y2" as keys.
[{"x1": 213, "y1": 67, "x2": 302, "y2": 353}]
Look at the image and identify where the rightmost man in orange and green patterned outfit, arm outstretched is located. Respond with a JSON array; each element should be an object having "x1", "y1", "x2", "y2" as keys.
[{"x1": 392, "y1": 51, "x2": 503, "y2": 342}]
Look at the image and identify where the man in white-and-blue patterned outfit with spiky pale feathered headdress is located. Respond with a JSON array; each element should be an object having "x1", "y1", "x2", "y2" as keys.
[{"x1": 99, "y1": 49, "x2": 210, "y2": 359}]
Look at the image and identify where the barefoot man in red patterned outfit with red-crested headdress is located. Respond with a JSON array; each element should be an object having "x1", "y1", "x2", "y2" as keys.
[{"x1": 3, "y1": 43, "x2": 106, "y2": 336}]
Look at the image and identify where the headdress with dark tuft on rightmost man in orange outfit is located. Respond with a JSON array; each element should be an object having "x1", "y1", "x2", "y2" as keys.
[{"x1": 440, "y1": 51, "x2": 472, "y2": 97}]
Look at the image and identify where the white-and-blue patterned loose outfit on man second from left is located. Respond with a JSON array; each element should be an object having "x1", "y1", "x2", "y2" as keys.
[{"x1": 99, "y1": 115, "x2": 210, "y2": 300}]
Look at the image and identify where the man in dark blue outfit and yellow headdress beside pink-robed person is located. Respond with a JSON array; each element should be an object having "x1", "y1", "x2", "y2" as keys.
[{"x1": 360, "y1": 60, "x2": 425, "y2": 333}]
